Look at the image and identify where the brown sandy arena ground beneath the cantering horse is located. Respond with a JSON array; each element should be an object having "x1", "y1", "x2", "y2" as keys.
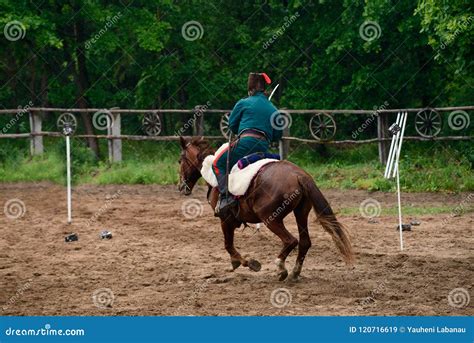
[{"x1": 0, "y1": 183, "x2": 474, "y2": 315}]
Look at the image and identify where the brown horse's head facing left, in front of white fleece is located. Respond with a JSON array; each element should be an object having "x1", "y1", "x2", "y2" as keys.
[{"x1": 178, "y1": 137, "x2": 212, "y2": 195}]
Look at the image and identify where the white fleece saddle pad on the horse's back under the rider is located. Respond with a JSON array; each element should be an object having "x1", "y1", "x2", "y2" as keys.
[{"x1": 201, "y1": 143, "x2": 279, "y2": 195}]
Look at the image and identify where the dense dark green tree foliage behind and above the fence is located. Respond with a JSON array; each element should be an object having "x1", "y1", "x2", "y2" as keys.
[{"x1": 0, "y1": 0, "x2": 474, "y2": 191}]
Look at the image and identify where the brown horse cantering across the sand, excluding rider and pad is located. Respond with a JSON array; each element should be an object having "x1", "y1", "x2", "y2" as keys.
[{"x1": 178, "y1": 137, "x2": 353, "y2": 280}]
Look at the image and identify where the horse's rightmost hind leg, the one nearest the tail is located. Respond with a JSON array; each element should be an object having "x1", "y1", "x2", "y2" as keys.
[{"x1": 290, "y1": 201, "x2": 311, "y2": 281}]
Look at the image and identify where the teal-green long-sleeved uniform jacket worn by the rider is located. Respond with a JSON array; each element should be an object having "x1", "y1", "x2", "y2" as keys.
[{"x1": 229, "y1": 92, "x2": 282, "y2": 142}]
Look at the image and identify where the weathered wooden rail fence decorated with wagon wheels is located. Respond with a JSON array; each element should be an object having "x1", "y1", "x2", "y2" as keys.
[{"x1": 0, "y1": 106, "x2": 474, "y2": 163}]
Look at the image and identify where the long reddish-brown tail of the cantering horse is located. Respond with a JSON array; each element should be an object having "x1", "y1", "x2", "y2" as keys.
[{"x1": 298, "y1": 176, "x2": 354, "y2": 264}]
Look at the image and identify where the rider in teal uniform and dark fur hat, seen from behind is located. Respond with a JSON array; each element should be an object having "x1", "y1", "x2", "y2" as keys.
[{"x1": 213, "y1": 73, "x2": 282, "y2": 218}]
